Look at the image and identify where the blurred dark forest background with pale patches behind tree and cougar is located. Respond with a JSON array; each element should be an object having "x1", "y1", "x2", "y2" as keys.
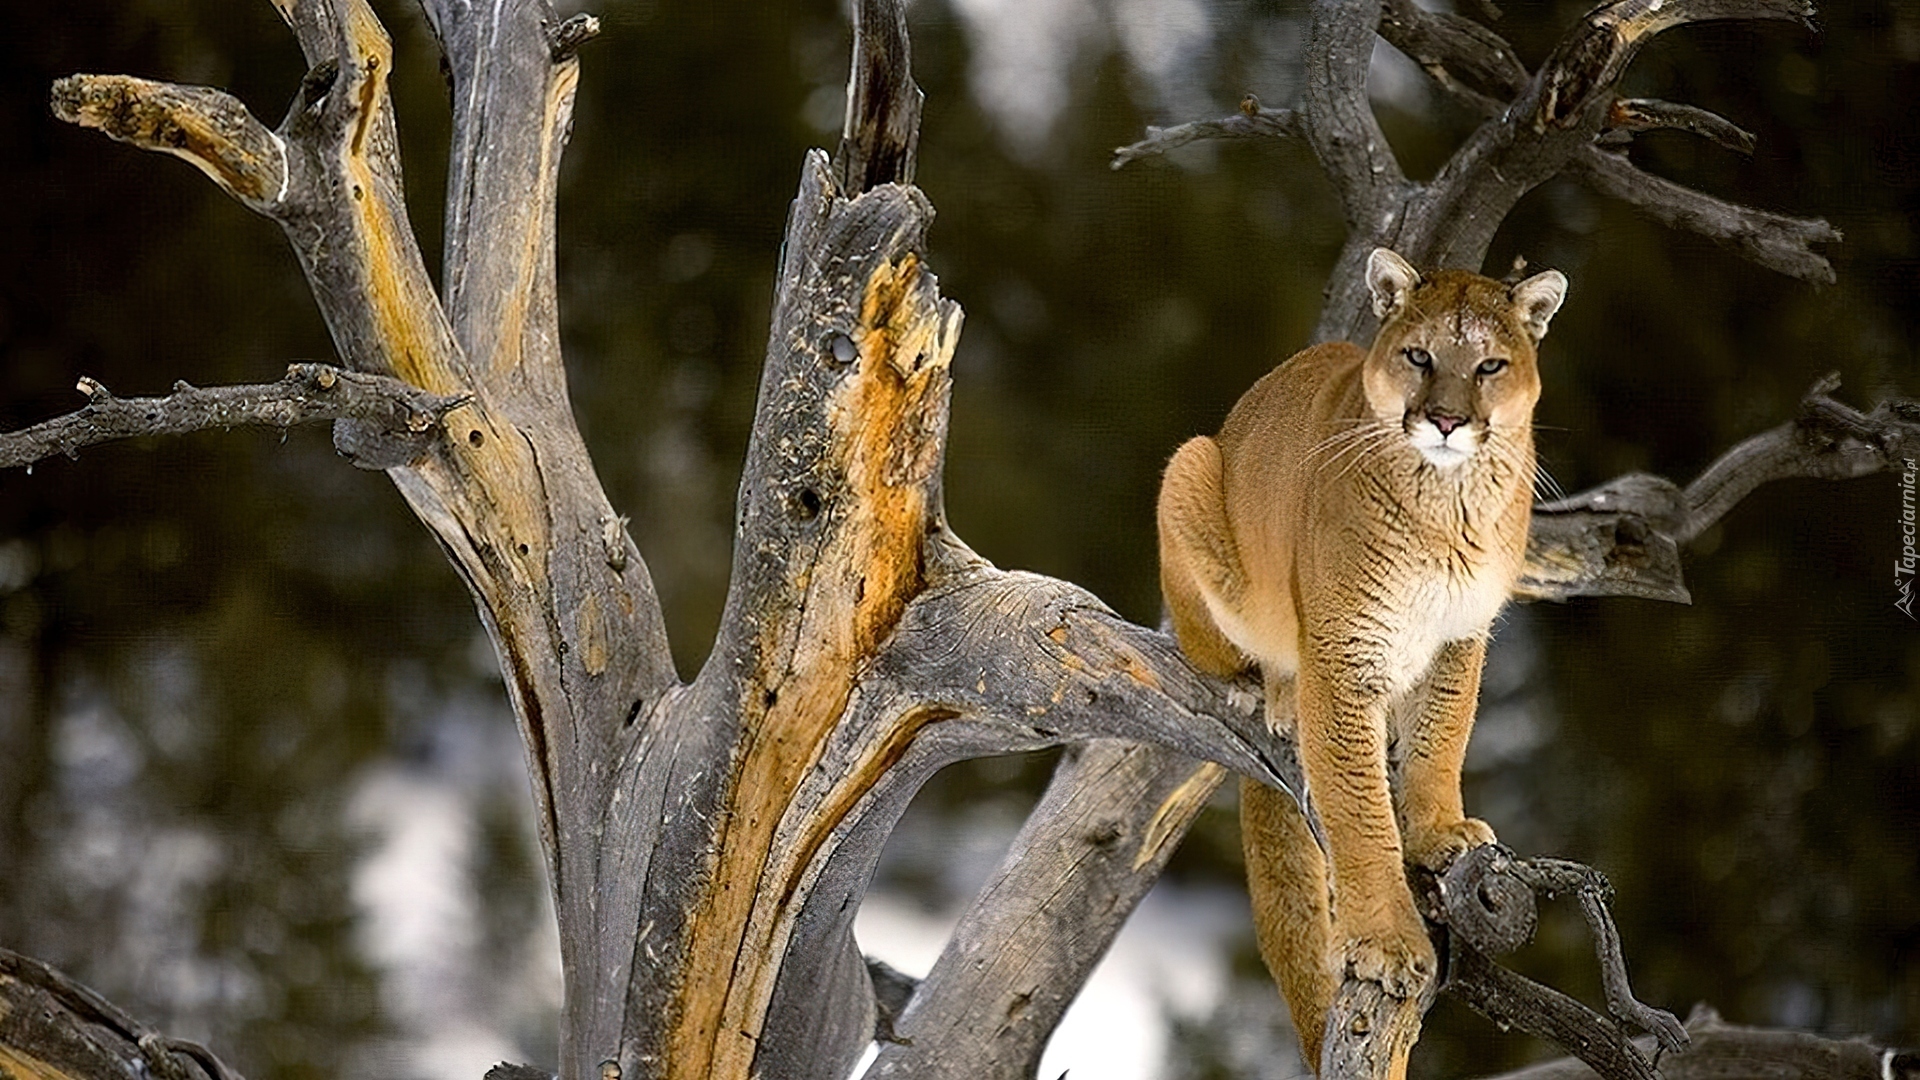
[{"x1": 0, "y1": 0, "x2": 1920, "y2": 1080}]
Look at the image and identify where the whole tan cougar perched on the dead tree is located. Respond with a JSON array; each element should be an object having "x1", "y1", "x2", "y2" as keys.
[{"x1": 1158, "y1": 248, "x2": 1567, "y2": 1068}]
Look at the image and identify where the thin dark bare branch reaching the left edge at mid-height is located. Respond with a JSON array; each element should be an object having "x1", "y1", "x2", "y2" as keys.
[{"x1": 0, "y1": 363, "x2": 467, "y2": 469}]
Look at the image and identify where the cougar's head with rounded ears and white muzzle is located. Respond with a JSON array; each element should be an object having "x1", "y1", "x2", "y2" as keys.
[{"x1": 1363, "y1": 248, "x2": 1567, "y2": 469}]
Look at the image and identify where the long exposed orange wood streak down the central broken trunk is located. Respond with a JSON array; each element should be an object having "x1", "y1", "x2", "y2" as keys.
[{"x1": 668, "y1": 254, "x2": 954, "y2": 1080}]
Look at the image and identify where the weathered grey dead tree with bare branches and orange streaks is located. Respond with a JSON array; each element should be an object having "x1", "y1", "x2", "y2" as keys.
[{"x1": 0, "y1": 0, "x2": 1920, "y2": 1080}]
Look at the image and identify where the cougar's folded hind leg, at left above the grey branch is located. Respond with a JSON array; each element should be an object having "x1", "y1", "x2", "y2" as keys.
[{"x1": 1156, "y1": 434, "x2": 1248, "y2": 676}]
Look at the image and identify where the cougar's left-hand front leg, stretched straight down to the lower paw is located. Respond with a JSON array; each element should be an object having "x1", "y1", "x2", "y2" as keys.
[{"x1": 1296, "y1": 632, "x2": 1438, "y2": 997}]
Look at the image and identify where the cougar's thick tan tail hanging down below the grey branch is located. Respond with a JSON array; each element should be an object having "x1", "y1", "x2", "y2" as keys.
[{"x1": 1240, "y1": 780, "x2": 1334, "y2": 1072}]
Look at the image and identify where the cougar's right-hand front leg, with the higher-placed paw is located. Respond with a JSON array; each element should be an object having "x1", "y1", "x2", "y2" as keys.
[{"x1": 1400, "y1": 638, "x2": 1494, "y2": 871}]
